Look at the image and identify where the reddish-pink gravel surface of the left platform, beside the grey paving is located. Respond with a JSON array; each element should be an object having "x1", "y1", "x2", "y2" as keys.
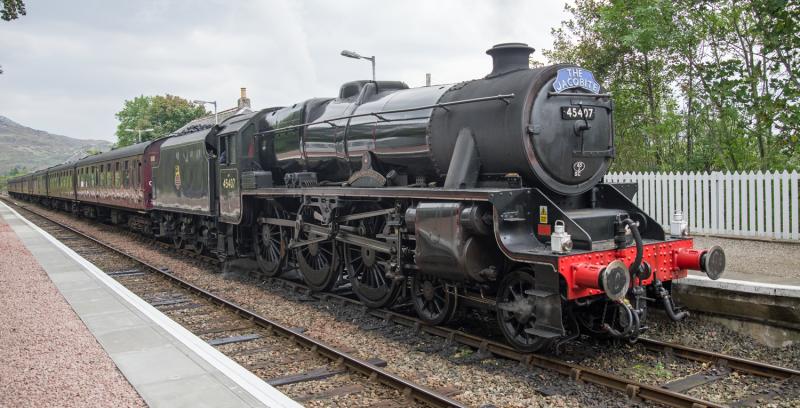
[{"x1": 0, "y1": 218, "x2": 146, "y2": 407}]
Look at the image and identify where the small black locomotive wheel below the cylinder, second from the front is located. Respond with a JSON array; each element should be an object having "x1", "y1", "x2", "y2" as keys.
[{"x1": 411, "y1": 274, "x2": 456, "y2": 325}]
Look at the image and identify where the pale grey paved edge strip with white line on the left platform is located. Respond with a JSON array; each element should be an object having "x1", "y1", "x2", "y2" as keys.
[{"x1": 0, "y1": 203, "x2": 300, "y2": 408}]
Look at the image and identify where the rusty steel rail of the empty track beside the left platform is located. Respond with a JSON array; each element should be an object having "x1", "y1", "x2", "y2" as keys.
[{"x1": 3, "y1": 198, "x2": 466, "y2": 408}]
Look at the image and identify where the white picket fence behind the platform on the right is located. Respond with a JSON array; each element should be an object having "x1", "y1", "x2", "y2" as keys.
[{"x1": 605, "y1": 171, "x2": 800, "y2": 240}]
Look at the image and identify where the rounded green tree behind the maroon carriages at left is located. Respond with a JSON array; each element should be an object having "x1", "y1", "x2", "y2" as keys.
[{"x1": 116, "y1": 95, "x2": 208, "y2": 147}]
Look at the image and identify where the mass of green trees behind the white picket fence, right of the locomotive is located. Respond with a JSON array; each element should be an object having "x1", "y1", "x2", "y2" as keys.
[{"x1": 545, "y1": 0, "x2": 800, "y2": 171}]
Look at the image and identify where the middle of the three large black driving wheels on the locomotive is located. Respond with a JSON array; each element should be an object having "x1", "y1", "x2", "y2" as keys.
[{"x1": 295, "y1": 225, "x2": 340, "y2": 292}]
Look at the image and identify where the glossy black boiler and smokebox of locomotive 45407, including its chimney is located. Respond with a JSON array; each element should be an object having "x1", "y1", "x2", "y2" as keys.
[{"x1": 266, "y1": 44, "x2": 614, "y2": 195}]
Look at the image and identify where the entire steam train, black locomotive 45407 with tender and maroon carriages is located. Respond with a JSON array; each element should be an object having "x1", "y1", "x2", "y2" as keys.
[{"x1": 9, "y1": 43, "x2": 725, "y2": 350}]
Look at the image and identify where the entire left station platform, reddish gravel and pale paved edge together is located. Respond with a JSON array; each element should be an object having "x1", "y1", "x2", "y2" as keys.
[{"x1": 0, "y1": 203, "x2": 300, "y2": 407}]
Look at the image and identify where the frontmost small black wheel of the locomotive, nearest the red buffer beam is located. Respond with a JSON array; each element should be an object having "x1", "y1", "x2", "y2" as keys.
[{"x1": 497, "y1": 268, "x2": 549, "y2": 352}]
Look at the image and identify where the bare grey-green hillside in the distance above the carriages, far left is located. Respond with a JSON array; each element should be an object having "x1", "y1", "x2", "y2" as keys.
[{"x1": 0, "y1": 115, "x2": 111, "y2": 175}]
